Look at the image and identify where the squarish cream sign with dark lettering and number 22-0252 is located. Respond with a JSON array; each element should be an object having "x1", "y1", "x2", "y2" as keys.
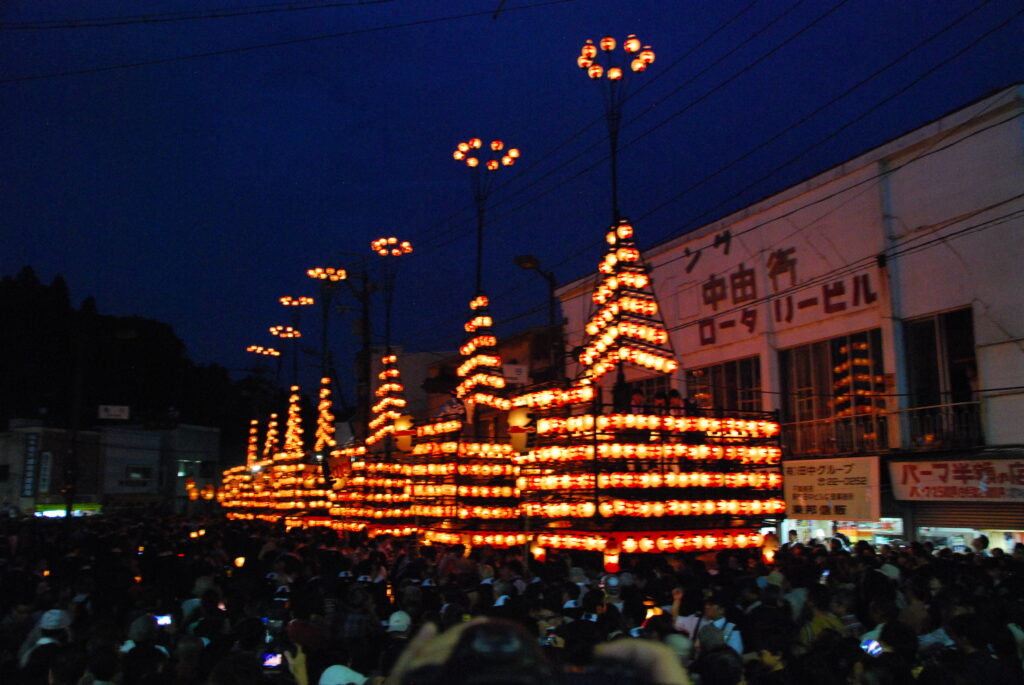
[{"x1": 782, "y1": 457, "x2": 881, "y2": 521}]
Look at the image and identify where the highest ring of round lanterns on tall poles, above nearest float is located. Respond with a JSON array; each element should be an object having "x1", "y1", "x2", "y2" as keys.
[{"x1": 577, "y1": 34, "x2": 654, "y2": 223}]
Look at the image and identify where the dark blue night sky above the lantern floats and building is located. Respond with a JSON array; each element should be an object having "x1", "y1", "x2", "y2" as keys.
[{"x1": 0, "y1": 0, "x2": 1024, "y2": 389}]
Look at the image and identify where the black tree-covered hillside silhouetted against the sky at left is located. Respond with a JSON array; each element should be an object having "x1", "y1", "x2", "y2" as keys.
[{"x1": 0, "y1": 267, "x2": 287, "y2": 456}]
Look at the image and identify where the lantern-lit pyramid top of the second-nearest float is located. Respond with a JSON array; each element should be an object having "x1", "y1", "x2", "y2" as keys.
[{"x1": 456, "y1": 294, "x2": 512, "y2": 410}]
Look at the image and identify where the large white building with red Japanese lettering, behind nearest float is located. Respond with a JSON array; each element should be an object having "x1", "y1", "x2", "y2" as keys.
[{"x1": 559, "y1": 85, "x2": 1024, "y2": 548}]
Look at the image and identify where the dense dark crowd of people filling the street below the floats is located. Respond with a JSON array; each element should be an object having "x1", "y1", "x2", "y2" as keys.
[{"x1": 0, "y1": 516, "x2": 1024, "y2": 685}]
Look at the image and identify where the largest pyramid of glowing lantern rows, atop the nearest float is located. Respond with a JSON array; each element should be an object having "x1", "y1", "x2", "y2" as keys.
[{"x1": 579, "y1": 219, "x2": 679, "y2": 382}]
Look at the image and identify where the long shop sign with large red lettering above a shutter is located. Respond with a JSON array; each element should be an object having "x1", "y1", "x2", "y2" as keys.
[{"x1": 889, "y1": 459, "x2": 1024, "y2": 504}]
